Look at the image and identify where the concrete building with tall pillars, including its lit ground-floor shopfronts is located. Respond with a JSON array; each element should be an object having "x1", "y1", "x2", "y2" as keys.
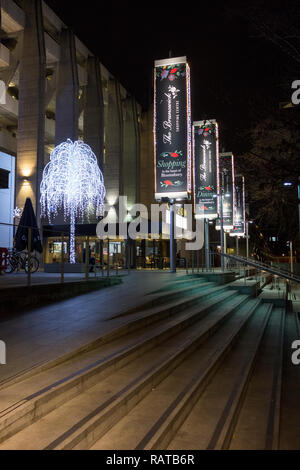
[{"x1": 0, "y1": 0, "x2": 195, "y2": 267}]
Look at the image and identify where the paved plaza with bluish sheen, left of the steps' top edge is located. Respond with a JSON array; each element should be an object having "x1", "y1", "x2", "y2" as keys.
[{"x1": 0, "y1": 271, "x2": 182, "y2": 382}]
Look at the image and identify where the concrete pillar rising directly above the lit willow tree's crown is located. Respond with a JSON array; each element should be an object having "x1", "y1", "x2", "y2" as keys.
[{"x1": 55, "y1": 28, "x2": 79, "y2": 145}]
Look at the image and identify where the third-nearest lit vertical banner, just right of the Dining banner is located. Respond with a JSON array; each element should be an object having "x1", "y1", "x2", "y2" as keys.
[{"x1": 216, "y1": 152, "x2": 235, "y2": 230}]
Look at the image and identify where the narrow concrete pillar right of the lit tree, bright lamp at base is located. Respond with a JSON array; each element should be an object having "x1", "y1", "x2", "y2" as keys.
[{"x1": 104, "y1": 79, "x2": 123, "y2": 205}]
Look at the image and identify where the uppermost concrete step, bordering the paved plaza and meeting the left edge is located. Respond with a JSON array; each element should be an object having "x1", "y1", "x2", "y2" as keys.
[{"x1": 0, "y1": 284, "x2": 239, "y2": 441}]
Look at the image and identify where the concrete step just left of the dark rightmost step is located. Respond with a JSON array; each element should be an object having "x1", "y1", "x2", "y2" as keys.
[{"x1": 168, "y1": 304, "x2": 272, "y2": 450}]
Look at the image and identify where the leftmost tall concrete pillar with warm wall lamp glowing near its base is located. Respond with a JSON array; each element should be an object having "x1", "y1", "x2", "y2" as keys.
[{"x1": 16, "y1": 0, "x2": 46, "y2": 218}]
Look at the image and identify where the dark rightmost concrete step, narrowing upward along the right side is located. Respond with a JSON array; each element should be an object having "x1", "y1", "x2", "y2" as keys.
[{"x1": 228, "y1": 308, "x2": 285, "y2": 450}]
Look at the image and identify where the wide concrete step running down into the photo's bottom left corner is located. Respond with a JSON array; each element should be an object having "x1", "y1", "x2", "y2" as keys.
[{"x1": 0, "y1": 296, "x2": 250, "y2": 449}]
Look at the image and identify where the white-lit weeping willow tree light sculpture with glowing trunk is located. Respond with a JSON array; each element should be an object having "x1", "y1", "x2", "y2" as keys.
[{"x1": 41, "y1": 139, "x2": 106, "y2": 264}]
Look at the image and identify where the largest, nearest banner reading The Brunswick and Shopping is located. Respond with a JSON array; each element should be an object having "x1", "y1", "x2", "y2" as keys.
[{"x1": 153, "y1": 57, "x2": 191, "y2": 200}]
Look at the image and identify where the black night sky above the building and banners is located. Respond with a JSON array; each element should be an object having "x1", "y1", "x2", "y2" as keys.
[{"x1": 46, "y1": 0, "x2": 299, "y2": 151}]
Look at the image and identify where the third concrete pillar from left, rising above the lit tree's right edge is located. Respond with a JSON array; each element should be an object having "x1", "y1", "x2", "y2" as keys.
[{"x1": 83, "y1": 57, "x2": 104, "y2": 171}]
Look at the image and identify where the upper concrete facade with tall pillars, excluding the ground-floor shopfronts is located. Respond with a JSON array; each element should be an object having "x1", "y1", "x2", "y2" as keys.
[{"x1": 0, "y1": 0, "x2": 142, "y2": 260}]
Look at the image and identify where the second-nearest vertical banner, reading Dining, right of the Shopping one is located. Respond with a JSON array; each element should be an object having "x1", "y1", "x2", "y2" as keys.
[{"x1": 193, "y1": 119, "x2": 219, "y2": 219}]
